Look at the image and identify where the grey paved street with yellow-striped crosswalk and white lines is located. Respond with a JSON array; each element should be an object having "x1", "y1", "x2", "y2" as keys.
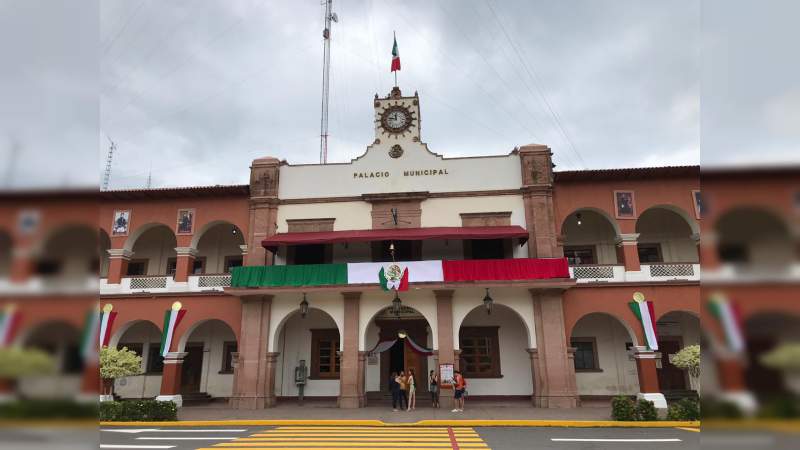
[{"x1": 100, "y1": 426, "x2": 700, "y2": 450}]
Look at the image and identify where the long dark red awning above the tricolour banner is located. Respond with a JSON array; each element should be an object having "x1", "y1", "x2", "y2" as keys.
[{"x1": 261, "y1": 225, "x2": 528, "y2": 251}]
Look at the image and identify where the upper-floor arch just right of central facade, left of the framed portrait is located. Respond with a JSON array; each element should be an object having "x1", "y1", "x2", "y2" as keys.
[{"x1": 560, "y1": 207, "x2": 621, "y2": 265}]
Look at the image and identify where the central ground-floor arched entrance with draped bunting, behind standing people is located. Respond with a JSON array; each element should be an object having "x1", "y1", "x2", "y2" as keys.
[{"x1": 365, "y1": 305, "x2": 435, "y2": 401}]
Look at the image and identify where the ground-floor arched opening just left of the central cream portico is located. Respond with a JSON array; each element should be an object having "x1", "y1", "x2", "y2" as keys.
[{"x1": 178, "y1": 319, "x2": 238, "y2": 404}]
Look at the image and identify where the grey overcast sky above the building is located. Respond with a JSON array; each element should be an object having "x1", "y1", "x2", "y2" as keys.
[{"x1": 0, "y1": 0, "x2": 800, "y2": 188}]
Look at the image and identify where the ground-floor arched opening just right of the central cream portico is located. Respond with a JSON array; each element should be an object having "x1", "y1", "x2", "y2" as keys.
[{"x1": 570, "y1": 313, "x2": 639, "y2": 399}]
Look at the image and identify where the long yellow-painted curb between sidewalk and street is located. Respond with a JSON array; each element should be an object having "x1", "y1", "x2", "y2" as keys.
[{"x1": 100, "y1": 419, "x2": 700, "y2": 428}]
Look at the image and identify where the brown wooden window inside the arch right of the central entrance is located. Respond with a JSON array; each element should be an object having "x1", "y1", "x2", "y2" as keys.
[{"x1": 459, "y1": 327, "x2": 502, "y2": 378}]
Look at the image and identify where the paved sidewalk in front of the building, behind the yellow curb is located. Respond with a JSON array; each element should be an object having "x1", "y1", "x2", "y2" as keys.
[{"x1": 178, "y1": 401, "x2": 611, "y2": 423}]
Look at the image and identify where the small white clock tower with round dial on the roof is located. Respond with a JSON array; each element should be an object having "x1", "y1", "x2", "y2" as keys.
[{"x1": 374, "y1": 86, "x2": 420, "y2": 146}]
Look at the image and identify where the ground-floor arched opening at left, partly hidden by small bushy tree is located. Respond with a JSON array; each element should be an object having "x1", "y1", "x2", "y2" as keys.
[{"x1": 109, "y1": 320, "x2": 164, "y2": 398}]
